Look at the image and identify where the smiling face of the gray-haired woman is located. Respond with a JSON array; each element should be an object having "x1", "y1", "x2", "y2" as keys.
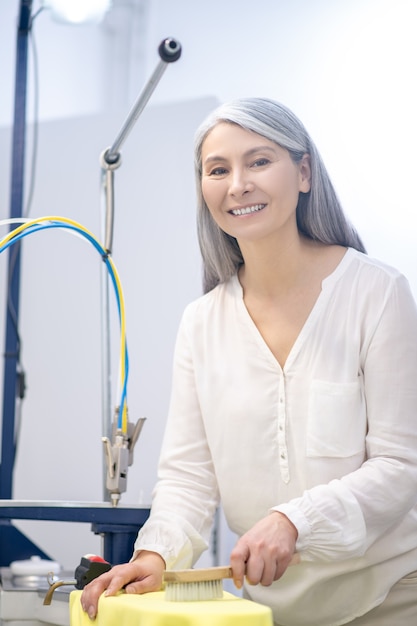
[{"x1": 201, "y1": 122, "x2": 310, "y2": 242}]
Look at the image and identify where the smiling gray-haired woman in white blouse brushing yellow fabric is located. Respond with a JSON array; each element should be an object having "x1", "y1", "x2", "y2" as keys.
[{"x1": 82, "y1": 98, "x2": 417, "y2": 626}]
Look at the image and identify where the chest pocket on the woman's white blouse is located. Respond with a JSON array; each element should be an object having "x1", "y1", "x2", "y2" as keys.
[{"x1": 307, "y1": 378, "x2": 366, "y2": 457}]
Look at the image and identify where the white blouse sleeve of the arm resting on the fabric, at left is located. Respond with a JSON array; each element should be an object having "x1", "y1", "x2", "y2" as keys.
[{"x1": 136, "y1": 312, "x2": 219, "y2": 568}]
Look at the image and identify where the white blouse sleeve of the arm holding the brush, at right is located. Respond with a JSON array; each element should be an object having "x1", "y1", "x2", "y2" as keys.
[{"x1": 274, "y1": 275, "x2": 417, "y2": 559}]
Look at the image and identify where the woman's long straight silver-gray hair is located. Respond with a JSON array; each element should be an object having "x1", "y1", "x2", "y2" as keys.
[{"x1": 194, "y1": 98, "x2": 365, "y2": 293}]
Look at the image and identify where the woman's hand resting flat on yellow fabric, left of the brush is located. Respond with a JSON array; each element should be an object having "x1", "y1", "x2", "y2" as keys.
[{"x1": 81, "y1": 551, "x2": 165, "y2": 619}]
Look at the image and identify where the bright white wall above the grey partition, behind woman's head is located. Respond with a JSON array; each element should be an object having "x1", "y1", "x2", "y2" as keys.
[{"x1": 0, "y1": 0, "x2": 417, "y2": 292}]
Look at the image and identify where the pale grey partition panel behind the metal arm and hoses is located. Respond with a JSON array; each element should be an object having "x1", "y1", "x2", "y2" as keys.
[{"x1": 0, "y1": 98, "x2": 215, "y2": 567}]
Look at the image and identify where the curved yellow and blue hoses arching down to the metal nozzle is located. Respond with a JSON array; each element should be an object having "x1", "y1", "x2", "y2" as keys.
[{"x1": 0, "y1": 216, "x2": 129, "y2": 434}]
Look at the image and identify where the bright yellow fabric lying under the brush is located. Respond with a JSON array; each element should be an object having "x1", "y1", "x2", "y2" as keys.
[{"x1": 70, "y1": 591, "x2": 273, "y2": 626}]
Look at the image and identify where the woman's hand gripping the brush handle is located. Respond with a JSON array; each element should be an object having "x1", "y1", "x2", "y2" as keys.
[{"x1": 230, "y1": 511, "x2": 298, "y2": 589}]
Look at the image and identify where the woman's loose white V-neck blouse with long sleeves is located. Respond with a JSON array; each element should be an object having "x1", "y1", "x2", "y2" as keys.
[{"x1": 135, "y1": 249, "x2": 417, "y2": 626}]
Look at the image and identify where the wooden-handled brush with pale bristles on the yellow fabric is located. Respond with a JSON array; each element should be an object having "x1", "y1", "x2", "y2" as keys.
[{"x1": 164, "y1": 554, "x2": 300, "y2": 602}]
